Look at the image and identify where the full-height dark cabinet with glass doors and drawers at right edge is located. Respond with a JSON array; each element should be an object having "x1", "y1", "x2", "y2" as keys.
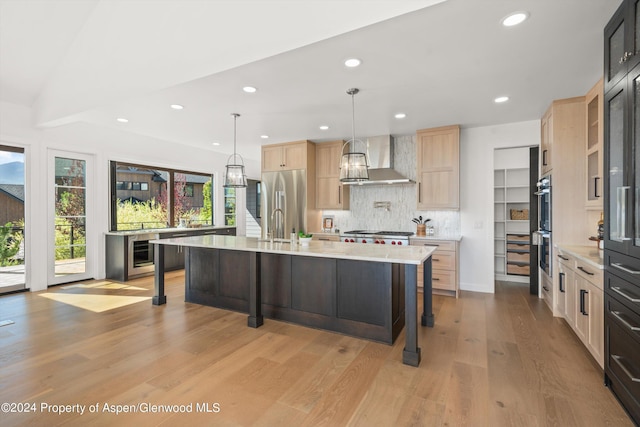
[{"x1": 604, "y1": 0, "x2": 640, "y2": 423}]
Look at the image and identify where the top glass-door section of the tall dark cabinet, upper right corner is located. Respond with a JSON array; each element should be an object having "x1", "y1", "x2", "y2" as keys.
[{"x1": 604, "y1": 0, "x2": 640, "y2": 92}]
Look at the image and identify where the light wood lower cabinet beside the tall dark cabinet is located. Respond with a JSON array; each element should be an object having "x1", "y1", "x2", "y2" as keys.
[{"x1": 557, "y1": 248, "x2": 604, "y2": 367}]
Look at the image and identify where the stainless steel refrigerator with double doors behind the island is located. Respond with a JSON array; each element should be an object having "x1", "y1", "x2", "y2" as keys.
[{"x1": 260, "y1": 169, "x2": 308, "y2": 239}]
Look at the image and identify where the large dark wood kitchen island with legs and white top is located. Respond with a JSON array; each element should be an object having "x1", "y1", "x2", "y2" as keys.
[{"x1": 151, "y1": 236, "x2": 434, "y2": 366}]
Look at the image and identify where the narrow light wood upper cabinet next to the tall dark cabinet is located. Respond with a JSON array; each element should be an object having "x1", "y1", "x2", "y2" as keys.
[{"x1": 585, "y1": 79, "x2": 604, "y2": 210}]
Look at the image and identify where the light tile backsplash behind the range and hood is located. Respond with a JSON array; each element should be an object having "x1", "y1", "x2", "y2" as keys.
[{"x1": 323, "y1": 135, "x2": 460, "y2": 237}]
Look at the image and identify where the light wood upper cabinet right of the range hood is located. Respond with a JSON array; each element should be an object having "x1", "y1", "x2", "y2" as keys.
[{"x1": 416, "y1": 125, "x2": 460, "y2": 210}]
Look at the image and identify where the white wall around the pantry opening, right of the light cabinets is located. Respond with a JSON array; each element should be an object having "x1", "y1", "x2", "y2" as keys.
[{"x1": 460, "y1": 120, "x2": 540, "y2": 293}]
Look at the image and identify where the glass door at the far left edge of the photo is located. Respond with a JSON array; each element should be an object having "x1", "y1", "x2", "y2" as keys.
[{"x1": 0, "y1": 145, "x2": 26, "y2": 294}]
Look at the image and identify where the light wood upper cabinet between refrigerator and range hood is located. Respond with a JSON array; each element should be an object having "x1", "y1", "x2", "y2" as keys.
[{"x1": 316, "y1": 141, "x2": 350, "y2": 209}]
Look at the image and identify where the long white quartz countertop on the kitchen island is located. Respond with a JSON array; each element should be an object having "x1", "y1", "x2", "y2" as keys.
[{"x1": 150, "y1": 235, "x2": 436, "y2": 265}]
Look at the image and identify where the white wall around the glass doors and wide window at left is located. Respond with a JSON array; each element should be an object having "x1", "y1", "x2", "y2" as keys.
[{"x1": 0, "y1": 102, "x2": 260, "y2": 291}]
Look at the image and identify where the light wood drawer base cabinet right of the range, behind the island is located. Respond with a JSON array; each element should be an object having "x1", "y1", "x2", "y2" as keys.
[{"x1": 410, "y1": 237, "x2": 460, "y2": 298}]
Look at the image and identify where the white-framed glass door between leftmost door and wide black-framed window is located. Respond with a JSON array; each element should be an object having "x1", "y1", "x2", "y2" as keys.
[{"x1": 48, "y1": 152, "x2": 93, "y2": 285}]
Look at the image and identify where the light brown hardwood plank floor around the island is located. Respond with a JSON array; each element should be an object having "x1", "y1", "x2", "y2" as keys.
[{"x1": 0, "y1": 273, "x2": 632, "y2": 426}]
